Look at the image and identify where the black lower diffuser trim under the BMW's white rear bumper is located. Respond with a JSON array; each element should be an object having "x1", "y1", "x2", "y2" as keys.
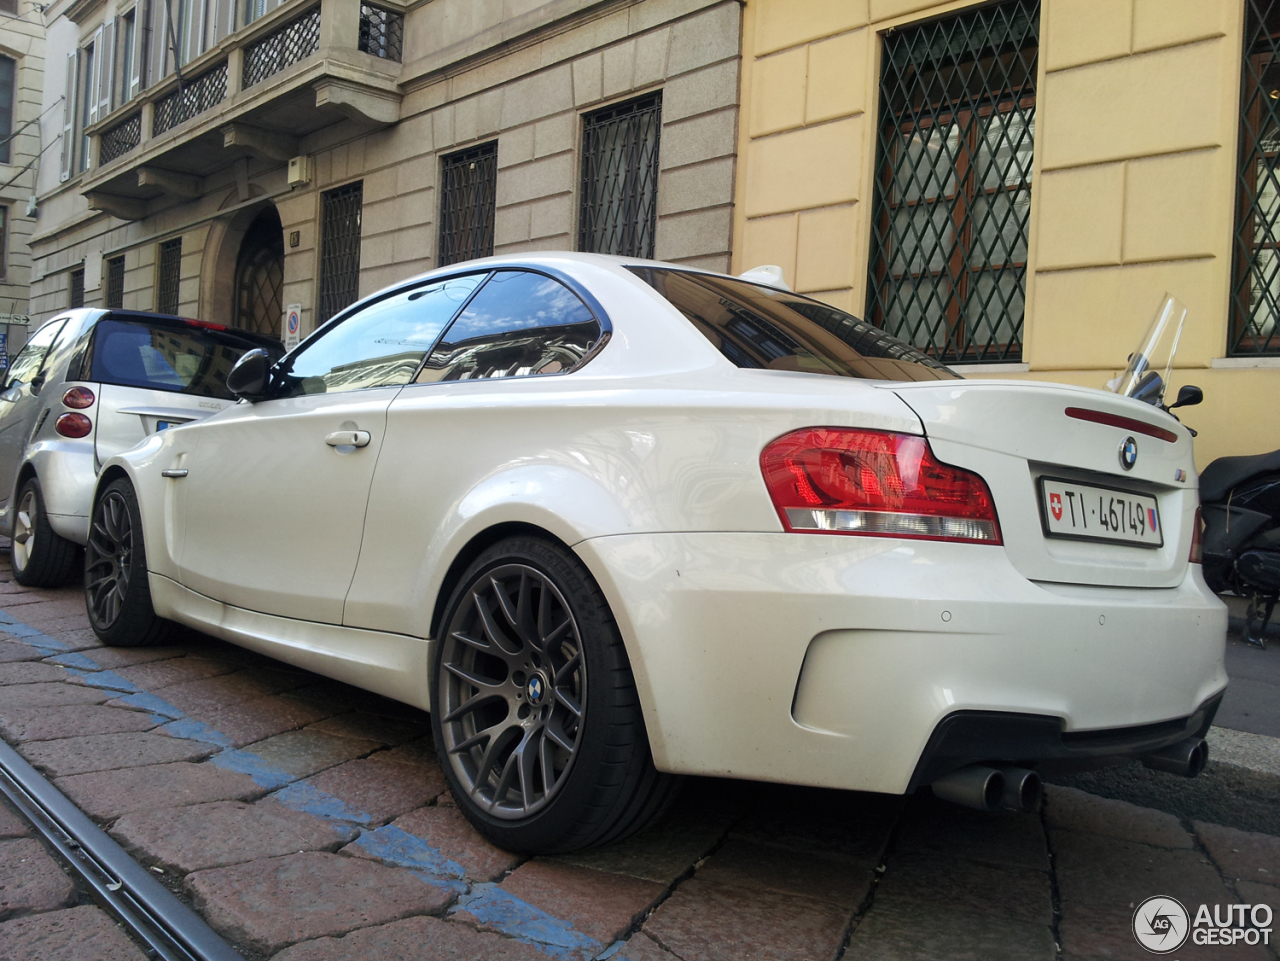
[{"x1": 910, "y1": 694, "x2": 1222, "y2": 788}]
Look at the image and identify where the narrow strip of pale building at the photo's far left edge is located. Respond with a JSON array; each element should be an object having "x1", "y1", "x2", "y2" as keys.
[{"x1": 0, "y1": 0, "x2": 47, "y2": 327}]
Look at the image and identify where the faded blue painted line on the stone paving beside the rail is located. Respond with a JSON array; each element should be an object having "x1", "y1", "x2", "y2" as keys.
[{"x1": 0, "y1": 609, "x2": 626, "y2": 961}]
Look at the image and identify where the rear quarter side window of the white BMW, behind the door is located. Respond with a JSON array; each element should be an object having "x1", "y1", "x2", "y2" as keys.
[{"x1": 417, "y1": 270, "x2": 600, "y2": 384}]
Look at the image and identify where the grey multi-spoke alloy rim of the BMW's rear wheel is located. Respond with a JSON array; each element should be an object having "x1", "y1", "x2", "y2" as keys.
[{"x1": 436, "y1": 563, "x2": 588, "y2": 820}]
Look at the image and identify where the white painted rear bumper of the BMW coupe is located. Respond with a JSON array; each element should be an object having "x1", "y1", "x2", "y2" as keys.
[{"x1": 576, "y1": 534, "x2": 1226, "y2": 793}]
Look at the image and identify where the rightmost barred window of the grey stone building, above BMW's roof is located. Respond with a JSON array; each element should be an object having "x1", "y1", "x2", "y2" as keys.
[{"x1": 577, "y1": 93, "x2": 662, "y2": 257}]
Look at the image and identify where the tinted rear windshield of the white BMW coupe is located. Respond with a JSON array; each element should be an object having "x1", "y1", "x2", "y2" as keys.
[{"x1": 628, "y1": 267, "x2": 960, "y2": 380}]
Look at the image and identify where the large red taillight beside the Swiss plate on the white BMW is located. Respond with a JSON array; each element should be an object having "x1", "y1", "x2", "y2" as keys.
[{"x1": 760, "y1": 427, "x2": 1001, "y2": 544}]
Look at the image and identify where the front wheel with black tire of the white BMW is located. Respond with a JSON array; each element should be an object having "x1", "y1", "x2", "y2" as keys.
[{"x1": 84, "y1": 477, "x2": 175, "y2": 647}]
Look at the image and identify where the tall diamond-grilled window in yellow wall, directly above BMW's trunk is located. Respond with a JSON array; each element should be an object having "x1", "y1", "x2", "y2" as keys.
[{"x1": 867, "y1": 0, "x2": 1039, "y2": 363}]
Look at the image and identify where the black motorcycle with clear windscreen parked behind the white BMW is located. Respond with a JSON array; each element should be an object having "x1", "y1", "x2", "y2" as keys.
[{"x1": 1108, "y1": 297, "x2": 1280, "y2": 647}]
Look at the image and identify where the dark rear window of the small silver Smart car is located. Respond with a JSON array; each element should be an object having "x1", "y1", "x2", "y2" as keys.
[{"x1": 86, "y1": 320, "x2": 270, "y2": 401}]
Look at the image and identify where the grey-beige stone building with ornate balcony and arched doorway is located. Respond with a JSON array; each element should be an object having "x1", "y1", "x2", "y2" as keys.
[{"x1": 31, "y1": 0, "x2": 741, "y2": 334}]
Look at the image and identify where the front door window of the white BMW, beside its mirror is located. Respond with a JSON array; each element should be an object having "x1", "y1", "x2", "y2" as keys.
[{"x1": 276, "y1": 274, "x2": 485, "y2": 397}]
